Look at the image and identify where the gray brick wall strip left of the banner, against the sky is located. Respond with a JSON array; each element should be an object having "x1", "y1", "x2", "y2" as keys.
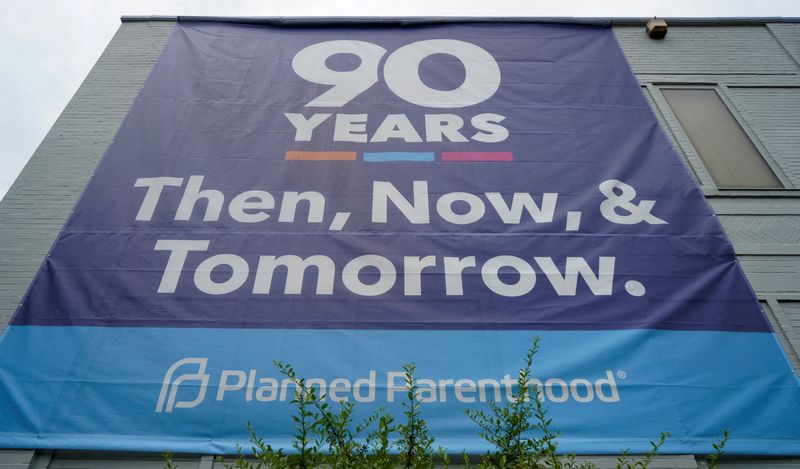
[{"x1": 0, "y1": 22, "x2": 174, "y2": 332}]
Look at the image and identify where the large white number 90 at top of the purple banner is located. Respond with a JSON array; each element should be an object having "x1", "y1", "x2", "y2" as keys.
[{"x1": 292, "y1": 39, "x2": 500, "y2": 108}]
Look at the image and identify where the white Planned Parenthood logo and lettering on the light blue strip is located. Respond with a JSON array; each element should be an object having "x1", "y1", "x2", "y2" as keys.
[{"x1": 155, "y1": 357, "x2": 627, "y2": 413}]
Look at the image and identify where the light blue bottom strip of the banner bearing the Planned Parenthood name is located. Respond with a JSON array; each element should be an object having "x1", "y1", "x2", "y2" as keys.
[{"x1": 0, "y1": 326, "x2": 800, "y2": 454}]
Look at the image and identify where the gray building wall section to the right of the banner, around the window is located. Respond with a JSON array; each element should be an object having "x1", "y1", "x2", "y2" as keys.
[{"x1": 614, "y1": 23, "x2": 800, "y2": 372}]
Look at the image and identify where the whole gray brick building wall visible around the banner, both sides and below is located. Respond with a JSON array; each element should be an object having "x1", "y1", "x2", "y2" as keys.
[{"x1": 0, "y1": 17, "x2": 800, "y2": 468}]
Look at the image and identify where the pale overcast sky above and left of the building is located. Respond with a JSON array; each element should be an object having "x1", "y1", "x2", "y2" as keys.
[{"x1": 0, "y1": 0, "x2": 800, "y2": 199}]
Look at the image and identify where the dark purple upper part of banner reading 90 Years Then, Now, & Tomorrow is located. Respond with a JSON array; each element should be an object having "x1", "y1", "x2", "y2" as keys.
[{"x1": 7, "y1": 22, "x2": 770, "y2": 332}]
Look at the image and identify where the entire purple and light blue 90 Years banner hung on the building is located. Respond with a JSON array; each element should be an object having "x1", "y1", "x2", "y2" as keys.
[{"x1": 0, "y1": 22, "x2": 800, "y2": 454}]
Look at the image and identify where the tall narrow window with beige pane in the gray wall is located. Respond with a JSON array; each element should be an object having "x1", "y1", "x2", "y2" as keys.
[{"x1": 661, "y1": 88, "x2": 783, "y2": 189}]
